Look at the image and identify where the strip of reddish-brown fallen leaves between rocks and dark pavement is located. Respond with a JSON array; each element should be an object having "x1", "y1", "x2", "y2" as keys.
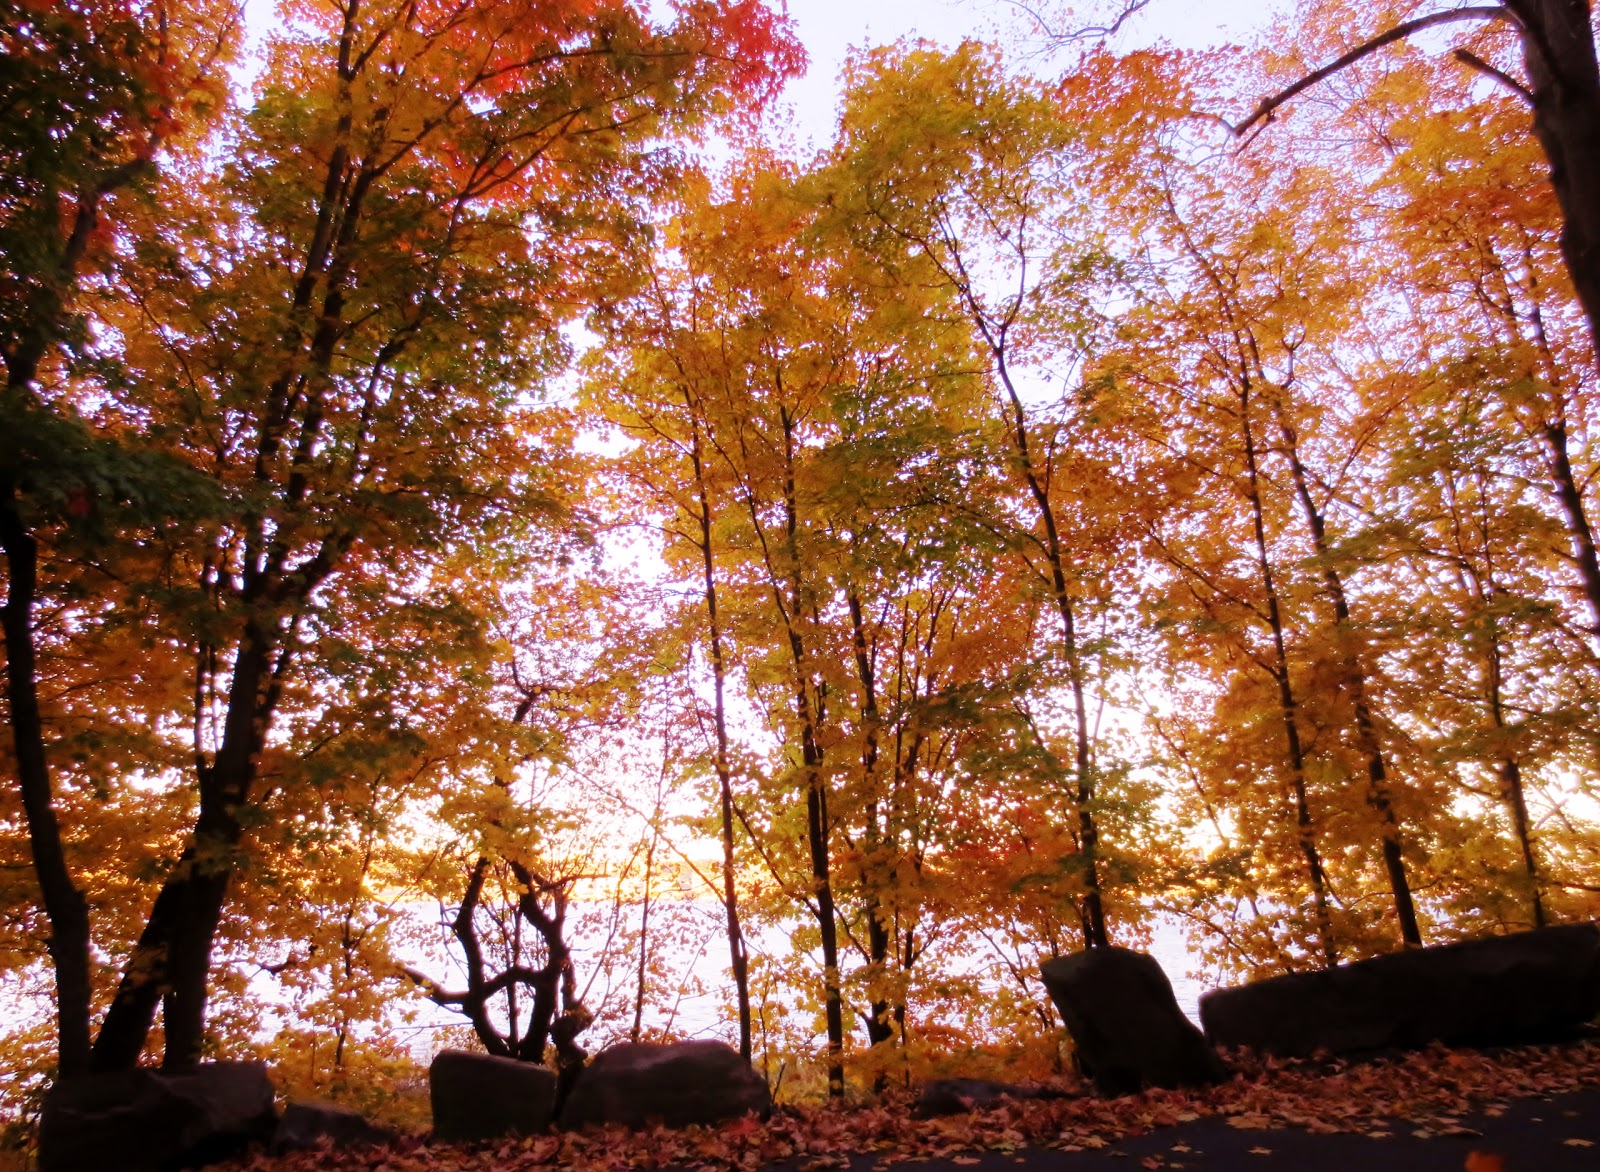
[{"x1": 227, "y1": 1041, "x2": 1600, "y2": 1172}]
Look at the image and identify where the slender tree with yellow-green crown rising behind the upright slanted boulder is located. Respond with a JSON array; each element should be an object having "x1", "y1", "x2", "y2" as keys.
[{"x1": 827, "y1": 43, "x2": 1145, "y2": 948}]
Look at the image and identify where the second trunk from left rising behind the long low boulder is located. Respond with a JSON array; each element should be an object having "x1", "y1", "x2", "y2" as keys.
[{"x1": 1275, "y1": 402, "x2": 1422, "y2": 948}]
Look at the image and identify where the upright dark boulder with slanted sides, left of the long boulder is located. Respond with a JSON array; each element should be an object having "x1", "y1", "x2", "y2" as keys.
[{"x1": 1040, "y1": 948, "x2": 1227, "y2": 1095}]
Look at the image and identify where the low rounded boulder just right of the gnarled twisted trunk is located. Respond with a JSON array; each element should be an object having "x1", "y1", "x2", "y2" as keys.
[{"x1": 562, "y1": 1042, "x2": 773, "y2": 1127}]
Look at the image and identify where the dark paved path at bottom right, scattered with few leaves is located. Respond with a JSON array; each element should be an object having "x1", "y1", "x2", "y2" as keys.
[{"x1": 883, "y1": 1090, "x2": 1600, "y2": 1172}]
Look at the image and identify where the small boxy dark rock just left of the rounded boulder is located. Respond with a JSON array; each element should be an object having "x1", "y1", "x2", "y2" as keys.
[{"x1": 427, "y1": 1050, "x2": 555, "y2": 1142}]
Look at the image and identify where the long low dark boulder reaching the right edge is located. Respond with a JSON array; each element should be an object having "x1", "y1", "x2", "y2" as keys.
[{"x1": 1200, "y1": 924, "x2": 1600, "y2": 1057}]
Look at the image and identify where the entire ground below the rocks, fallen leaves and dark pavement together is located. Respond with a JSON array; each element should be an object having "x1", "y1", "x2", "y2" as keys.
[{"x1": 227, "y1": 1041, "x2": 1600, "y2": 1172}]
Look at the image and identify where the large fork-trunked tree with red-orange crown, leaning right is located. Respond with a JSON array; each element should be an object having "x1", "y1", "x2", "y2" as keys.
[{"x1": 3, "y1": 3, "x2": 794, "y2": 1070}]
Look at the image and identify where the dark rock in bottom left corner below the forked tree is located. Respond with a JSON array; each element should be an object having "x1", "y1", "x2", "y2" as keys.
[{"x1": 38, "y1": 1062, "x2": 277, "y2": 1172}]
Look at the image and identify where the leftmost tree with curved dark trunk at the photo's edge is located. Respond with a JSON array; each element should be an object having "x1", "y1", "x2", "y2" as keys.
[{"x1": 0, "y1": 0, "x2": 238, "y2": 1074}]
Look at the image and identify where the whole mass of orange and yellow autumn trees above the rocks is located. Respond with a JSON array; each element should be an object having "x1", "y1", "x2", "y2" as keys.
[{"x1": 0, "y1": 0, "x2": 1600, "y2": 1146}]
